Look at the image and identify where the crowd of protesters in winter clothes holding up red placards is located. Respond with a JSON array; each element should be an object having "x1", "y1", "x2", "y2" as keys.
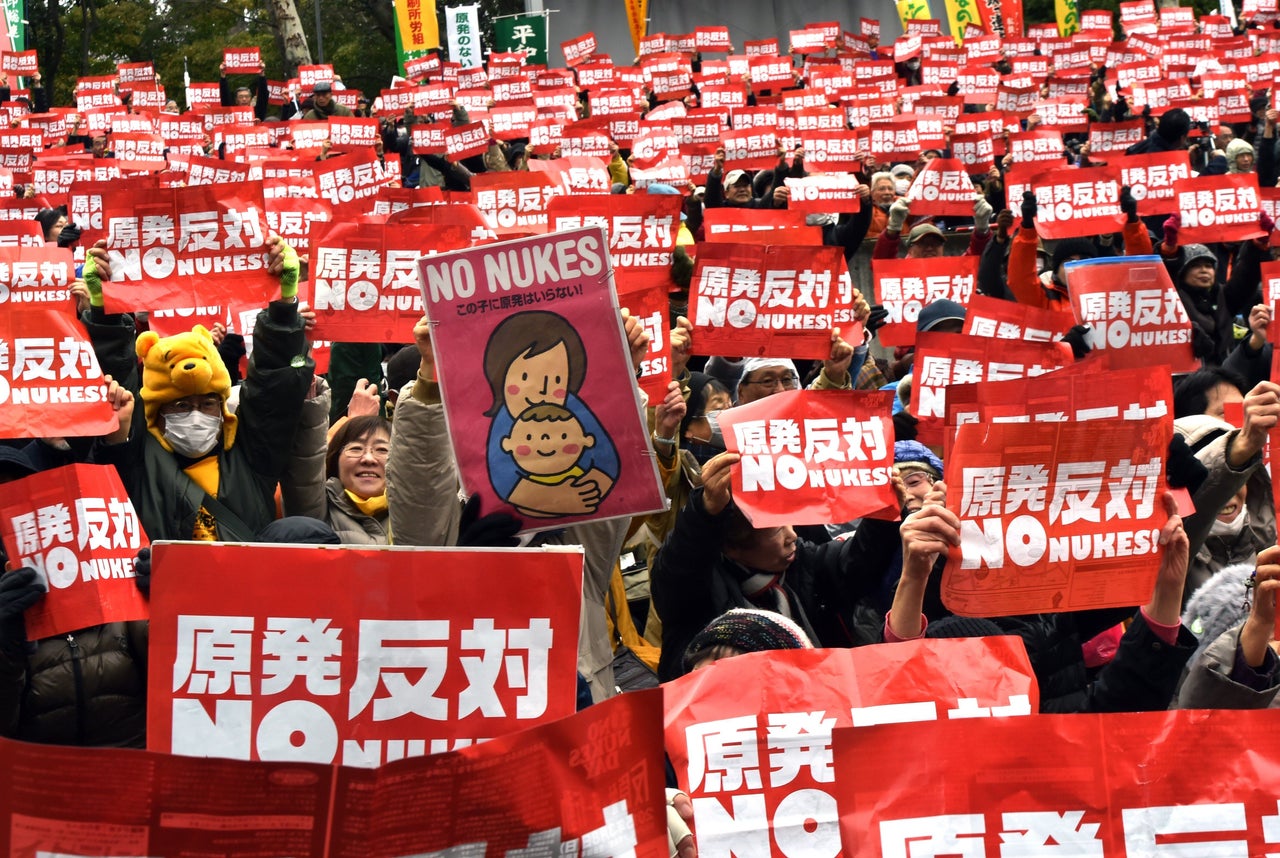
[{"x1": 0, "y1": 3, "x2": 1280, "y2": 850}]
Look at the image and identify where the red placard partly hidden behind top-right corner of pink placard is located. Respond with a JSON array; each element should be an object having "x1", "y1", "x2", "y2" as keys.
[{"x1": 547, "y1": 193, "x2": 684, "y2": 273}]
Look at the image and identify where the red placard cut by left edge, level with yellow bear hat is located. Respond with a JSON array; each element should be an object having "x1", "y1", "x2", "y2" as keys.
[{"x1": 0, "y1": 309, "x2": 116, "y2": 438}]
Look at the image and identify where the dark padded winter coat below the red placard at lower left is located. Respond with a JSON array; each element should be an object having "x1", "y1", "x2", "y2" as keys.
[{"x1": 0, "y1": 622, "x2": 147, "y2": 748}]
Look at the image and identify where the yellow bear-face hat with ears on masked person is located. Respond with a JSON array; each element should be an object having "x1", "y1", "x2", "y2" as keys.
[{"x1": 134, "y1": 325, "x2": 236, "y2": 452}]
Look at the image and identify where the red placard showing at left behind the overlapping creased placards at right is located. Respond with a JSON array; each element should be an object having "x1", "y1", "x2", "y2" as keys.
[{"x1": 910, "y1": 330, "x2": 1073, "y2": 447}]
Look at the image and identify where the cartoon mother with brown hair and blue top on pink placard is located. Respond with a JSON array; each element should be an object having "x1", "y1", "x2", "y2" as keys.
[{"x1": 484, "y1": 310, "x2": 620, "y2": 516}]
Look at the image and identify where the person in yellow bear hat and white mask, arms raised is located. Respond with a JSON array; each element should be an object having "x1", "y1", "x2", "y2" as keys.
[{"x1": 84, "y1": 236, "x2": 315, "y2": 542}]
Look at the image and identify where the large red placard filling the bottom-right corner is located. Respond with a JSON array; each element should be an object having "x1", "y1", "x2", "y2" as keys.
[{"x1": 834, "y1": 709, "x2": 1280, "y2": 858}]
